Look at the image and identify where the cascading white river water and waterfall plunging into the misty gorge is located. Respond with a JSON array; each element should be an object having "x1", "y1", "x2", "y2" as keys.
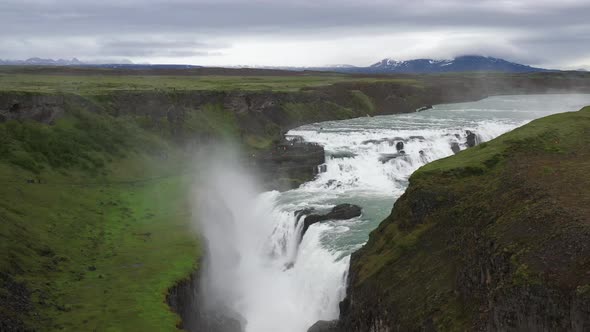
[{"x1": 198, "y1": 95, "x2": 590, "y2": 332}]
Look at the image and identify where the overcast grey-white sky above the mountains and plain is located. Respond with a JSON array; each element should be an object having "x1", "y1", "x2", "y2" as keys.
[{"x1": 0, "y1": 0, "x2": 590, "y2": 69}]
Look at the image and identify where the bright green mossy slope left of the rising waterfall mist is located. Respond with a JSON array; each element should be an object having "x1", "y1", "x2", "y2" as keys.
[{"x1": 0, "y1": 108, "x2": 200, "y2": 331}]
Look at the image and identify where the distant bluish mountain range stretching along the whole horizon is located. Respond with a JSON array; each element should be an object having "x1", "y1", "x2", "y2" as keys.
[{"x1": 0, "y1": 55, "x2": 564, "y2": 74}]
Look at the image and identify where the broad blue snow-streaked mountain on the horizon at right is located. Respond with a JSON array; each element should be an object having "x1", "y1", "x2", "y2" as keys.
[{"x1": 368, "y1": 55, "x2": 547, "y2": 73}]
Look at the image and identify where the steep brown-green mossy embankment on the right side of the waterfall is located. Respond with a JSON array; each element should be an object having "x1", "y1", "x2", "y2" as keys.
[{"x1": 338, "y1": 107, "x2": 590, "y2": 332}]
